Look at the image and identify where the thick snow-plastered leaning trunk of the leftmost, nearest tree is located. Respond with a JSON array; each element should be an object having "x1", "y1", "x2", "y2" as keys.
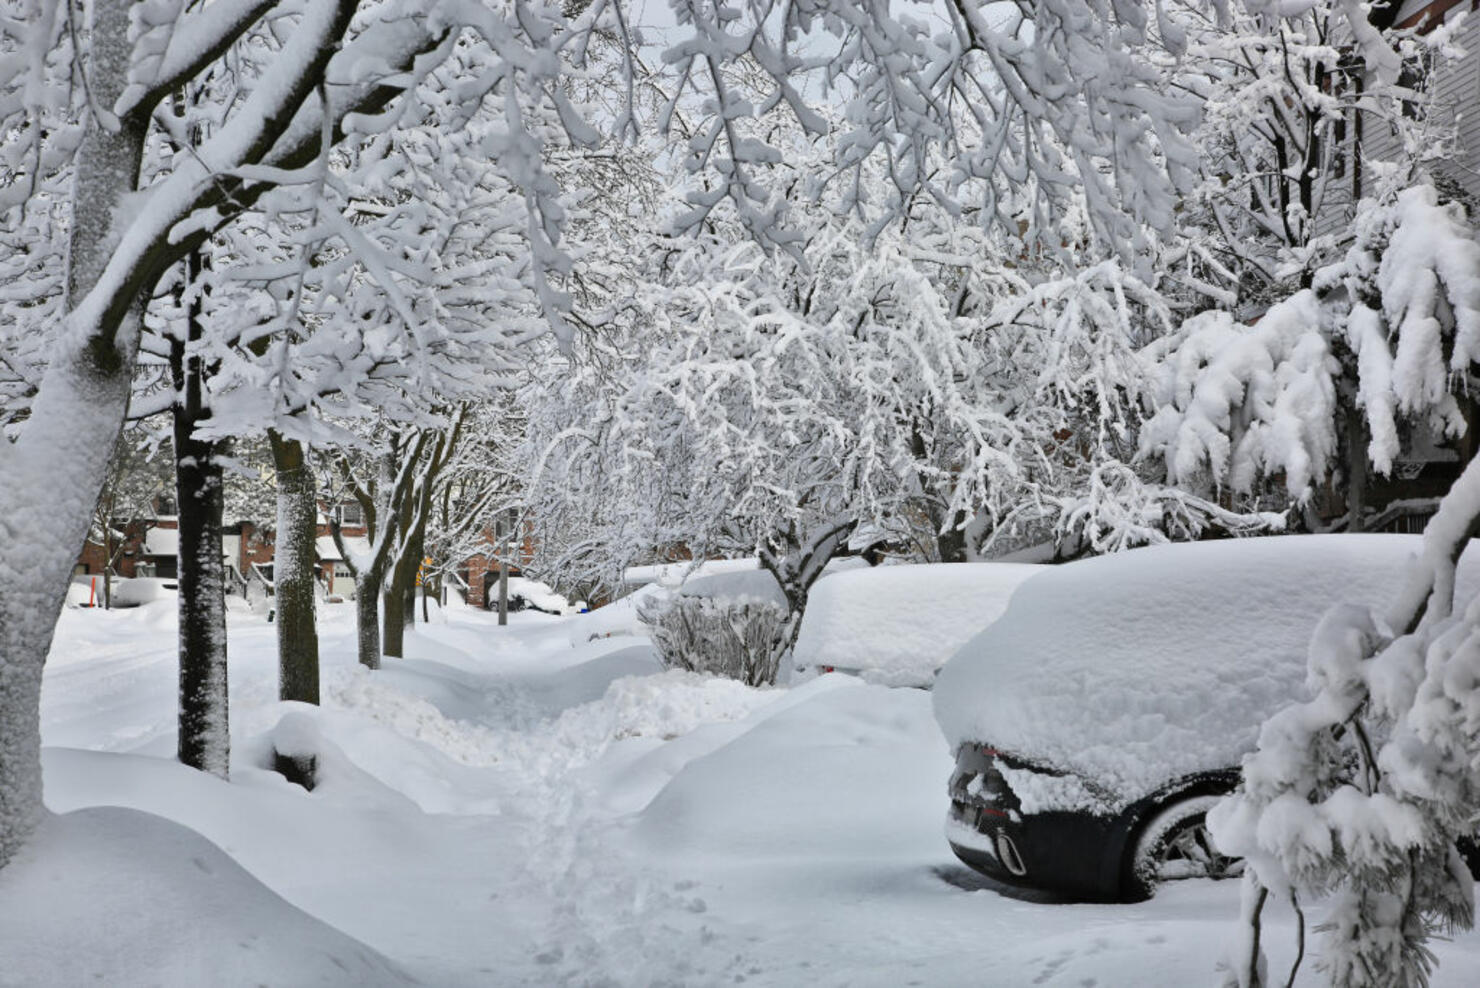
[{"x1": 0, "y1": 3, "x2": 148, "y2": 868}]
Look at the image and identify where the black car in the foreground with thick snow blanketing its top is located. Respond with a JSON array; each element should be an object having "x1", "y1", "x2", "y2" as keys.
[{"x1": 934, "y1": 535, "x2": 1480, "y2": 901}]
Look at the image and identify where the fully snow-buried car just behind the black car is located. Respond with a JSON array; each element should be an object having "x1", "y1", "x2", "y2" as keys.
[{"x1": 793, "y1": 562, "x2": 1042, "y2": 686}]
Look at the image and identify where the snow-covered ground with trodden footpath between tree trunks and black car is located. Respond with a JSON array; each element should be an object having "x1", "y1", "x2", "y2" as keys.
[{"x1": 17, "y1": 602, "x2": 1480, "y2": 988}]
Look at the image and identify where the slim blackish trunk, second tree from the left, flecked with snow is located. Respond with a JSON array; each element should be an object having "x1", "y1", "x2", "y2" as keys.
[{"x1": 170, "y1": 245, "x2": 231, "y2": 778}]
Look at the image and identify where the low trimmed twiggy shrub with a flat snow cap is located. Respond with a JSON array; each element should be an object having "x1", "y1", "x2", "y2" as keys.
[{"x1": 638, "y1": 595, "x2": 787, "y2": 686}]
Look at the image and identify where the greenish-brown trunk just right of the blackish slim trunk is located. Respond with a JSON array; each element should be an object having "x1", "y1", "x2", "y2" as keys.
[{"x1": 268, "y1": 432, "x2": 318, "y2": 704}]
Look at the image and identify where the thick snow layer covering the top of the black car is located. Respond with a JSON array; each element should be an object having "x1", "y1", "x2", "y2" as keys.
[{"x1": 935, "y1": 535, "x2": 1480, "y2": 802}]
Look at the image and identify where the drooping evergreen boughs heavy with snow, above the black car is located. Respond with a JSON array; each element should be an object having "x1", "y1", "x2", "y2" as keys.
[{"x1": 1140, "y1": 185, "x2": 1480, "y2": 527}]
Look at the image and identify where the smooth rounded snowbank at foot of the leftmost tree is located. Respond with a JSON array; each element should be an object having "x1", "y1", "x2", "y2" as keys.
[{"x1": 0, "y1": 808, "x2": 413, "y2": 988}]
